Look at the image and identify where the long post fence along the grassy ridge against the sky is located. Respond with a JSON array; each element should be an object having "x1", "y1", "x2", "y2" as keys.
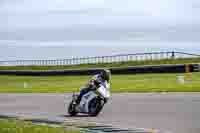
[{"x1": 0, "y1": 51, "x2": 200, "y2": 66}]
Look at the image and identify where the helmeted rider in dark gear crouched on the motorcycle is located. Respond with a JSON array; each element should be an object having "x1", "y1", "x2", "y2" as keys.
[{"x1": 76, "y1": 70, "x2": 111, "y2": 104}]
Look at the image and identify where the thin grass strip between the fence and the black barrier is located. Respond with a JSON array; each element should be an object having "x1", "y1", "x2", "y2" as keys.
[{"x1": 0, "y1": 58, "x2": 200, "y2": 70}]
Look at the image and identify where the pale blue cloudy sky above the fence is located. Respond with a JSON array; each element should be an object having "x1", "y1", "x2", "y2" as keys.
[{"x1": 0, "y1": 0, "x2": 200, "y2": 60}]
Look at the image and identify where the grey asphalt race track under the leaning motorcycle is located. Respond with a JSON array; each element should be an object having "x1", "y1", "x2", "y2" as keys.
[{"x1": 0, "y1": 93, "x2": 200, "y2": 133}]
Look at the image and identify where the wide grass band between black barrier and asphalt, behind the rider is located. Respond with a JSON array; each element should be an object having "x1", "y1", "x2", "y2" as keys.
[{"x1": 0, "y1": 72, "x2": 200, "y2": 93}]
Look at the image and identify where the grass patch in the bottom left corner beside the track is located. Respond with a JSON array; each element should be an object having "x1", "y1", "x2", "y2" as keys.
[{"x1": 0, "y1": 119, "x2": 79, "y2": 133}]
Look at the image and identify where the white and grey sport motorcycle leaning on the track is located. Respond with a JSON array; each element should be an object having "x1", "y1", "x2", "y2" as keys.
[{"x1": 68, "y1": 82, "x2": 110, "y2": 116}]
